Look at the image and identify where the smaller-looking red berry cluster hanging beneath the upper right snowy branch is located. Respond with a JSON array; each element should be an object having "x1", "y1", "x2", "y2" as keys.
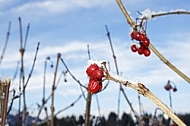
[{"x1": 131, "y1": 31, "x2": 151, "y2": 57}]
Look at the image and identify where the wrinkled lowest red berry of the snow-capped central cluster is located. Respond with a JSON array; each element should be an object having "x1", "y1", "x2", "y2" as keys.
[{"x1": 88, "y1": 79, "x2": 100, "y2": 93}]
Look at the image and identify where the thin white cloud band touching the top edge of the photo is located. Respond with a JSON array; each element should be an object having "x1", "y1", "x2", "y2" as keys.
[{"x1": 9, "y1": 0, "x2": 113, "y2": 15}]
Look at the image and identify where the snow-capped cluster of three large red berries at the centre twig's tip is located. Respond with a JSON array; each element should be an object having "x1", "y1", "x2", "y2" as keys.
[{"x1": 86, "y1": 63, "x2": 104, "y2": 93}]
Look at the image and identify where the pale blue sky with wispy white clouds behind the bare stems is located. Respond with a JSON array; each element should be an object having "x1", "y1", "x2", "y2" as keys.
[{"x1": 0, "y1": 0, "x2": 190, "y2": 118}]
